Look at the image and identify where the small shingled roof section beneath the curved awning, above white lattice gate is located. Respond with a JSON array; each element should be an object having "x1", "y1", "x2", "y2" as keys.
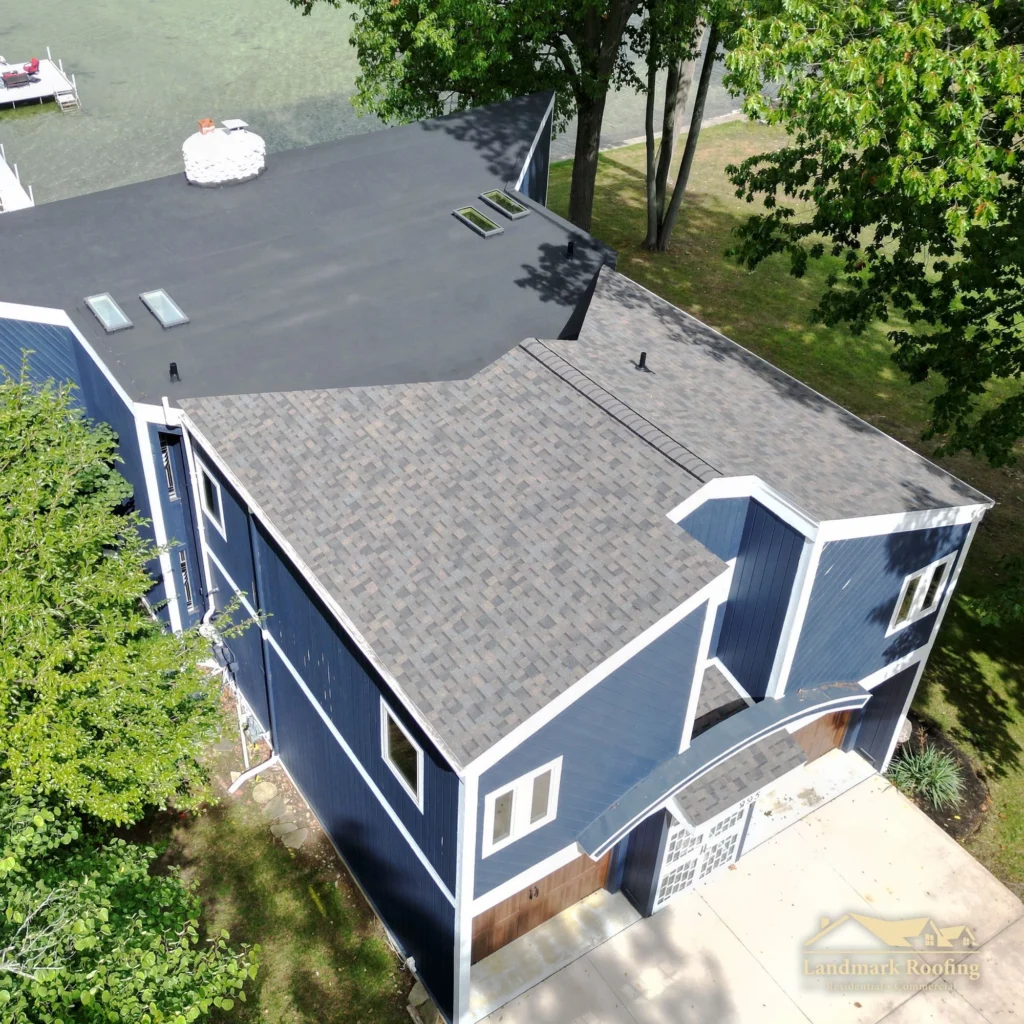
[{"x1": 675, "y1": 729, "x2": 807, "y2": 825}]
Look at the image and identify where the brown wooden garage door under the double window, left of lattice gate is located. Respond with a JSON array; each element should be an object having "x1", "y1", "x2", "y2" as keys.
[{"x1": 472, "y1": 852, "x2": 611, "y2": 964}]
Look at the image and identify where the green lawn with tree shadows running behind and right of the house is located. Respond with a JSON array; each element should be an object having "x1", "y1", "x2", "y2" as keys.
[{"x1": 550, "y1": 122, "x2": 1024, "y2": 895}]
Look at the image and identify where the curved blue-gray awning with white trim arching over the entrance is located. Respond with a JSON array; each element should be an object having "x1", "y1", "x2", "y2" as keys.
[{"x1": 577, "y1": 683, "x2": 870, "y2": 859}]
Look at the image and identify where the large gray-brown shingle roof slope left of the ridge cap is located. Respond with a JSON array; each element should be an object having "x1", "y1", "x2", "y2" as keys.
[{"x1": 181, "y1": 348, "x2": 724, "y2": 764}]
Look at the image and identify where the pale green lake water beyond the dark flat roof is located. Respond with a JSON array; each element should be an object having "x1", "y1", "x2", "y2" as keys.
[{"x1": 0, "y1": 0, "x2": 736, "y2": 203}]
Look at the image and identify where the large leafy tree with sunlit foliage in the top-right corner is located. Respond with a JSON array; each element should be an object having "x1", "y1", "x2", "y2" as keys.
[{"x1": 726, "y1": 0, "x2": 1024, "y2": 465}]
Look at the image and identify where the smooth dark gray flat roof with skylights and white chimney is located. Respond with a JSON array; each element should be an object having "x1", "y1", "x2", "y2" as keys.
[{"x1": 0, "y1": 95, "x2": 609, "y2": 403}]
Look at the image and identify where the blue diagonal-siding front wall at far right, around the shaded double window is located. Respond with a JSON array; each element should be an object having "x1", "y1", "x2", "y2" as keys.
[{"x1": 786, "y1": 525, "x2": 969, "y2": 689}]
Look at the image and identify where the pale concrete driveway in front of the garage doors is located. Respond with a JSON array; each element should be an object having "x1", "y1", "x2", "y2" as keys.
[{"x1": 487, "y1": 775, "x2": 1024, "y2": 1024}]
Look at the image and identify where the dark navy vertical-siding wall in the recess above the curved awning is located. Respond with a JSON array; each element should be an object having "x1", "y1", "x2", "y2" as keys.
[{"x1": 717, "y1": 501, "x2": 805, "y2": 700}]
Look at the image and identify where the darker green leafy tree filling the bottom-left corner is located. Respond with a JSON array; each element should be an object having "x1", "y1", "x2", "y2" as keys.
[{"x1": 0, "y1": 784, "x2": 259, "y2": 1024}]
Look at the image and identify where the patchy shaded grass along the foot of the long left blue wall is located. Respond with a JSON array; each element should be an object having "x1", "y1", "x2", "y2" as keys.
[{"x1": 150, "y1": 723, "x2": 411, "y2": 1024}]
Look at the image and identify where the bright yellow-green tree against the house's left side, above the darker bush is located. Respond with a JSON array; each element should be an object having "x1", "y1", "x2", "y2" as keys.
[{"x1": 0, "y1": 372, "x2": 242, "y2": 823}]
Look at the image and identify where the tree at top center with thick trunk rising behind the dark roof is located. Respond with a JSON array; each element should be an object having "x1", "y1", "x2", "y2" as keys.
[{"x1": 289, "y1": 0, "x2": 655, "y2": 229}]
